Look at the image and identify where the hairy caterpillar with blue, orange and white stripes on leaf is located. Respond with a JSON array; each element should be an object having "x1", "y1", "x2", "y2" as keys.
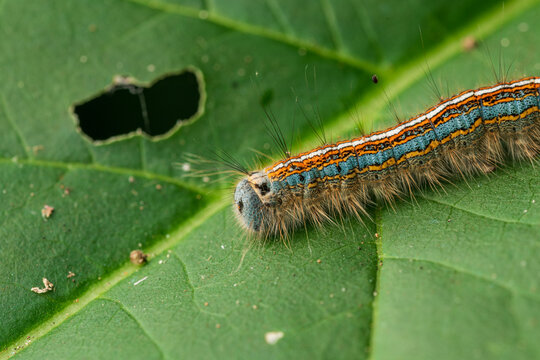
[{"x1": 233, "y1": 77, "x2": 540, "y2": 237}]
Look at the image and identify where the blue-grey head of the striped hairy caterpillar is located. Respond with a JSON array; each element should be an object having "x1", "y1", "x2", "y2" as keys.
[{"x1": 234, "y1": 171, "x2": 274, "y2": 233}]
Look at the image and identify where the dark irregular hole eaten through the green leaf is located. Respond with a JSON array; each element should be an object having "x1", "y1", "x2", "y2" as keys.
[{"x1": 74, "y1": 70, "x2": 203, "y2": 141}]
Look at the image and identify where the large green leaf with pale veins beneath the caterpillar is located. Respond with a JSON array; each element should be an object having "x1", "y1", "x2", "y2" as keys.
[{"x1": 0, "y1": 0, "x2": 540, "y2": 359}]
